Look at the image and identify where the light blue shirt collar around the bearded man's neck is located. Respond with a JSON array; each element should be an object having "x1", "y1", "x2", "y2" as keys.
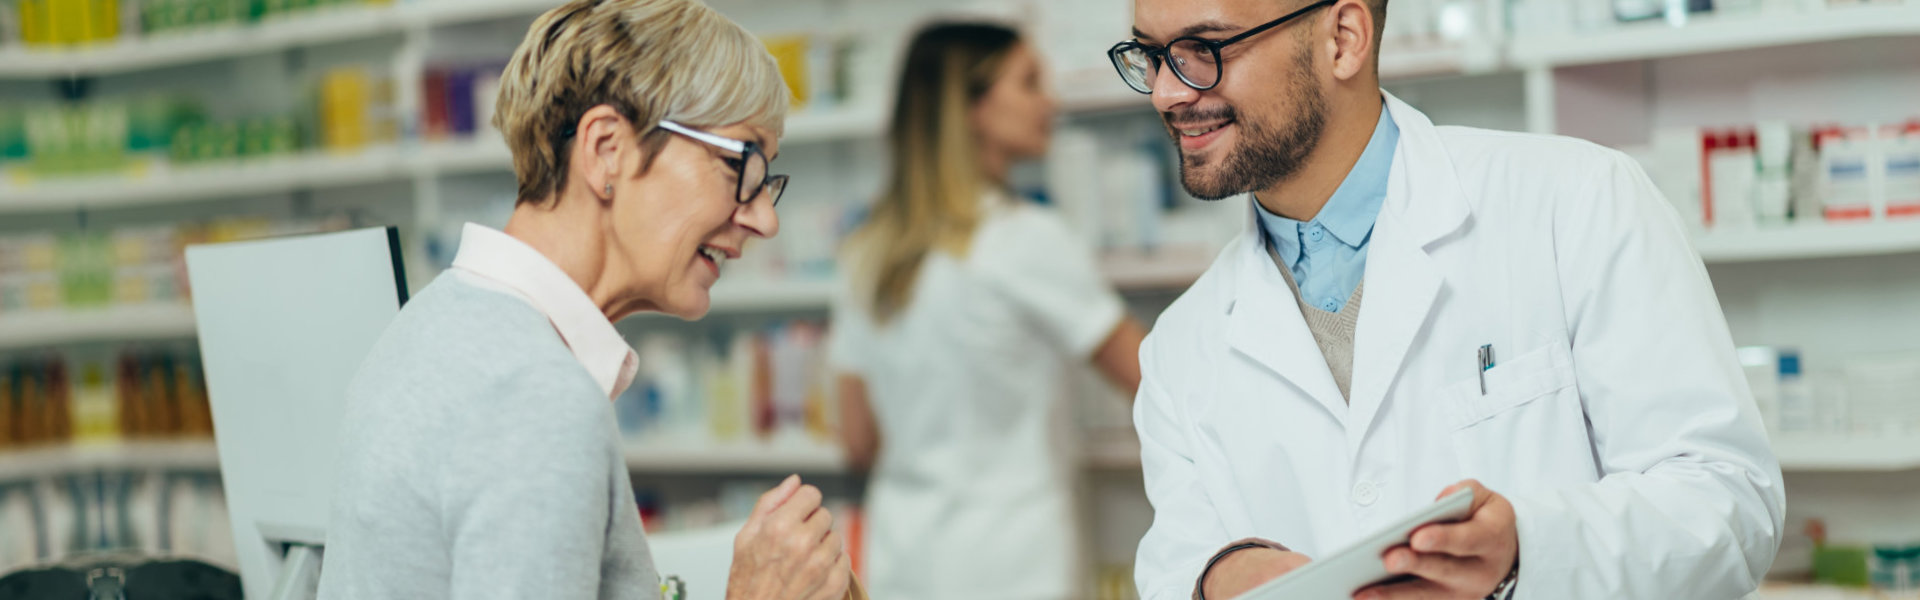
[{"x1": 1254, "y1": 106, "x2": 1400, "y2": 250}]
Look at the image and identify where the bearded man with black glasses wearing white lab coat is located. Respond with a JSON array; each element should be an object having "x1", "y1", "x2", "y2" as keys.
[{"x1": 1110, "y1": 0, "x2": 1786, "y2": 600}]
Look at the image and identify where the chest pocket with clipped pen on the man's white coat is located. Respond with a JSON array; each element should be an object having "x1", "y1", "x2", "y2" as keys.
[{"x1": 1446, "y1": 342, "x2": 1574, "y2": 429}]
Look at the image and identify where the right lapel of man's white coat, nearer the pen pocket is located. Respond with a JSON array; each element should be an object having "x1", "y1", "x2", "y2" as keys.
[{"x1": 1346, "y1": 92, "x2": 1471, "y2": 452}]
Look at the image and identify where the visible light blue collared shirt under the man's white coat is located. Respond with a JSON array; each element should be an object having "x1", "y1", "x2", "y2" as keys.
[{"x1": 1254, "y1": 106, "x2": 1400, "y2": 312}]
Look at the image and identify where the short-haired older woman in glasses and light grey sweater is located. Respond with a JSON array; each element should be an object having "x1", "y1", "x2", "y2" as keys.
[{"x1": 321, "y1": 0, "x2": 851, "y2": 600}]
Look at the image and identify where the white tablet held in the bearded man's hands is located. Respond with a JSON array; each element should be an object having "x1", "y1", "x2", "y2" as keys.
[{"x1": 1235, "y1": 488, "x2": 1473, "y2": 600}]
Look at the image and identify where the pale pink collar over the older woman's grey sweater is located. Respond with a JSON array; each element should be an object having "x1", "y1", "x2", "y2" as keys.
[{"x1": 453, "y1": 223, "x2": 639, "y2": 398}]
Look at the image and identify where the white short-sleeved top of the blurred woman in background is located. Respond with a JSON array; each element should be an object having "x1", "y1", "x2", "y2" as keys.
[{"x1": 829, "y1": 194, "x2": 1123, "y2": 600}]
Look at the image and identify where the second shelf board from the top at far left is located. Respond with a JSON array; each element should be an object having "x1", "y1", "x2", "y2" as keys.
[{"x1": 0, "y1": 148, "x2": 417, "y2": 213}]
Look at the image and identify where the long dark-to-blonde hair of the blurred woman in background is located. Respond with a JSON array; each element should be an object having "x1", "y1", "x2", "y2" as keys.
[{"x1": 852, "y1": 23, "x2": 1020, "y2": 323}]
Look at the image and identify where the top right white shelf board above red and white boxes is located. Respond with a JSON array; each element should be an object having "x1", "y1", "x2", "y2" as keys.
[{"x1": 1507, "y1": 4, "x2": 1920, "y2": 67}]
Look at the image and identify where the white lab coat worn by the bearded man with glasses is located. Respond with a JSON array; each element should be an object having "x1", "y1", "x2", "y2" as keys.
[{"x1": 1133, "y1": 96, "x2": 1786, "y2": 600}]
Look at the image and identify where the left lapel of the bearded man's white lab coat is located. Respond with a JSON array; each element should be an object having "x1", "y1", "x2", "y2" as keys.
[{"x1": 1225, "y1": 213, "x2": 1346, "y2": 421}]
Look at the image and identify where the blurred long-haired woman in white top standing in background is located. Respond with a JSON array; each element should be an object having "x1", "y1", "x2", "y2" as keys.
[{"x1": 829, "y1": 25, "x2": 1142, "y2": 600}]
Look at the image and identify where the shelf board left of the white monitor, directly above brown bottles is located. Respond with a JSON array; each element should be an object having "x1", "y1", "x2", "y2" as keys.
[{"x1": 0, "y1": 304, "x2": 194, "y2": 350}]
